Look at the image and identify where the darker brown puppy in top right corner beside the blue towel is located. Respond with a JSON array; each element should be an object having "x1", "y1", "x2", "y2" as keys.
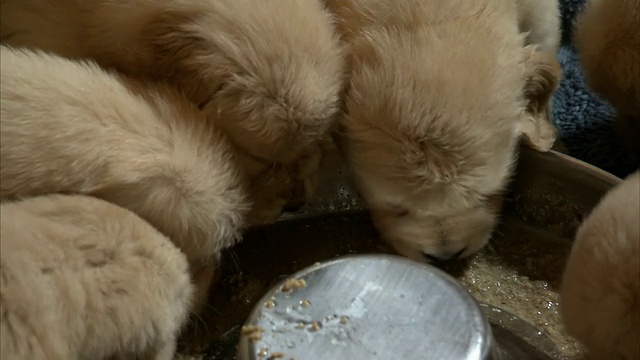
[{"x1": 574, "y1": 0, "x2": 640, "y2": 154}]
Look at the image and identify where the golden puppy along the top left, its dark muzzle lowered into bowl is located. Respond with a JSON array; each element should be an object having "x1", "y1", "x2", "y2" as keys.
[{"x1": 0, "y1": 0, "x2": 344, "y2": 211}]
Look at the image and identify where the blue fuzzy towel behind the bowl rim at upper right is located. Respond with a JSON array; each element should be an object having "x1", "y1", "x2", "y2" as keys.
[{"x1": 552, "y1": 0, "x2": 640, "y2": 177}]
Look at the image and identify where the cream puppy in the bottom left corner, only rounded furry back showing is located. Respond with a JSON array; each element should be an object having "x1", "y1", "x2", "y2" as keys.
[{"x1": 0, "y1": 195, "x2": 193, "y2": 360}]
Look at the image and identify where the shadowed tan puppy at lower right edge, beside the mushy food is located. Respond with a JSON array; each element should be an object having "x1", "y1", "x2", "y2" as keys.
[{"x1": 560, "y1": 172, "x2": 640, "y2": 360}]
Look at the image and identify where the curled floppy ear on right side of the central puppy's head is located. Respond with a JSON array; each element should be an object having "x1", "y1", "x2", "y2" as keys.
[{"x1": 521, "y1": 45, "x2": 562, "y2": 152}]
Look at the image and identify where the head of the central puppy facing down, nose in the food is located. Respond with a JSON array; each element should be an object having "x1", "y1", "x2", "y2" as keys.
[{"x1": 336, "y1": 34, "x2": 524, "y2": 261}]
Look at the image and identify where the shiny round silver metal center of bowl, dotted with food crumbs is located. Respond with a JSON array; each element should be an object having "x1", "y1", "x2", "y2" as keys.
[{"x1": 238, "y1": 255, "x2": 493, "y2": 360}]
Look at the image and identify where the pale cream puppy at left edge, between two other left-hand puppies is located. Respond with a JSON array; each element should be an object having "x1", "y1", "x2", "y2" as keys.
[{"x1": 0, "y1": 46, "x2": 248, "y2": 268}]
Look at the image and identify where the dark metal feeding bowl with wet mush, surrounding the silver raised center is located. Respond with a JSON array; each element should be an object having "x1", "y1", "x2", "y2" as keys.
[{"x1": 175, "y1": 147, "x2": 621, "y2": 360}]
